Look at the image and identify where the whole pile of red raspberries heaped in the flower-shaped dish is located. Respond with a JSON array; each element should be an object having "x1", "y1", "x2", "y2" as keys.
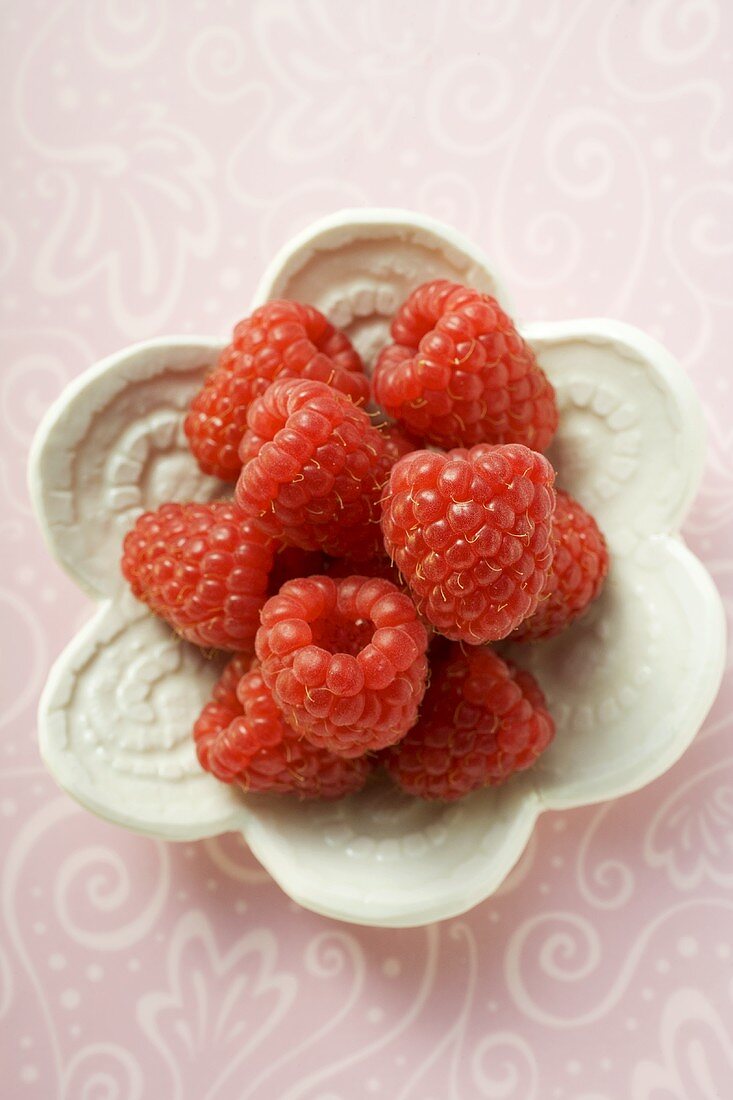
[{"x1": 122, "y1": 279, "x2": 609, "y2": 801}]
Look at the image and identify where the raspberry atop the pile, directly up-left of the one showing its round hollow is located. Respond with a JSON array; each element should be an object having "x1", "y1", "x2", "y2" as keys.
[{"x1": 237, "y1": 378, "x2": 390, "y2": 560}]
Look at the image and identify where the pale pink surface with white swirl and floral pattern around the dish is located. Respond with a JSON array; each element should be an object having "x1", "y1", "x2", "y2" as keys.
[{"x1": 0, "y1": 0, "x2": 733, "y2": 1100}]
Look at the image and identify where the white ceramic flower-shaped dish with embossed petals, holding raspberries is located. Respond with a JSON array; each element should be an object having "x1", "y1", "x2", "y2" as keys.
[{"x1": 30, "y1": 210, "x2": 725, "y2": 926}]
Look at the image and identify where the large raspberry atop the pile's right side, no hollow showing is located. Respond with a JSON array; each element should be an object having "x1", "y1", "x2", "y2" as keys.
[{"x1": 382, "y1": 443, "x2": 555, "y2": 644}]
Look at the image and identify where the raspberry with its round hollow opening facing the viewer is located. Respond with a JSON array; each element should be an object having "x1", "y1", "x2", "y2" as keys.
[{"x1": 255, "y1": 576, "x2": 427, "y2": 757}]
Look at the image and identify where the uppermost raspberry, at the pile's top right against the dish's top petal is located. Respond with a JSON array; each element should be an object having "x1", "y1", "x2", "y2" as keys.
[{"x1": 372, "y1": 279, "x2": 558, "y2": 451}]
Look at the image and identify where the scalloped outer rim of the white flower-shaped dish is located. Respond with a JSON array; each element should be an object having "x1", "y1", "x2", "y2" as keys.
[{"x1": 29, "y1": 210, "x2": 725, "y2": 927}]
